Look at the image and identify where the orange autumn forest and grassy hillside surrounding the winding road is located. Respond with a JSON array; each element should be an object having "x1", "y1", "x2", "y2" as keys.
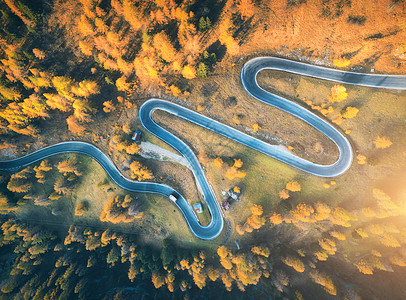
[{"x1": 0, "y1": 0, "x2": 406, "y2": 300}]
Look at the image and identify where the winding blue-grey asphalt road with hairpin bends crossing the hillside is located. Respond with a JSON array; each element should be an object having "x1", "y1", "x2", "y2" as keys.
[{"x1": 0, "y1": 57, "x2": 406, "y2": 240}]
